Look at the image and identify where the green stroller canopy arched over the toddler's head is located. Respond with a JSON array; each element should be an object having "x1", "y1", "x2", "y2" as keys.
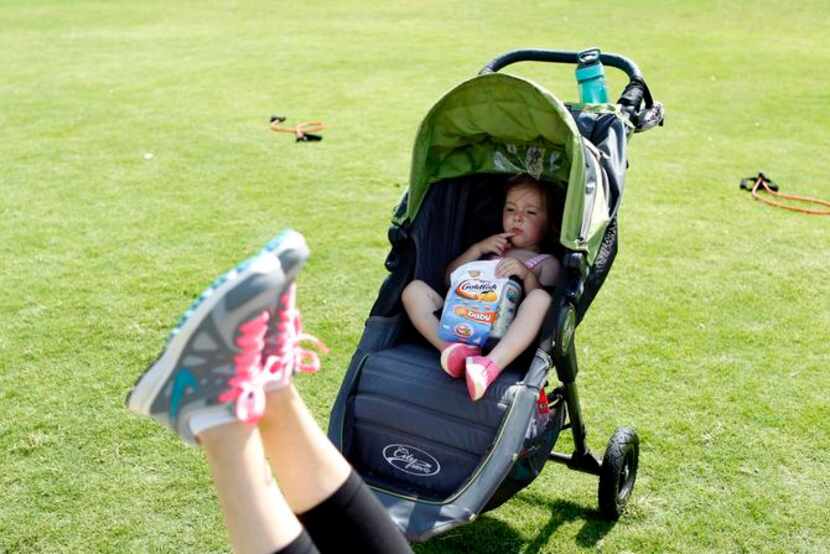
[{"x1": 400, "y1": 73, "x2": 610, "y2": 263}]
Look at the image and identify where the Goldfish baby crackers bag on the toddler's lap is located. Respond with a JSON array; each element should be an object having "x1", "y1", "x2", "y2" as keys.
[{"x1": 438, "y1": 260, "x2": 522, "y2": 346}]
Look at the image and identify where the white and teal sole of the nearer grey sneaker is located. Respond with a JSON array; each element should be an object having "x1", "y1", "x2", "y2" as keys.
[{"x1": 126, "y1": 230, "x2": 307, "y2": 416}]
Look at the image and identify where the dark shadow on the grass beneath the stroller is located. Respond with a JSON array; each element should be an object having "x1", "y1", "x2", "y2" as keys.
[{"x1": 414, "y1": 493, "x2": 616, "y2": 554}]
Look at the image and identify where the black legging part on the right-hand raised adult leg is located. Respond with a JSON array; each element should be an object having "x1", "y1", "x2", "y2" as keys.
[{"x1": 297, "y1": 470, "x2": 412, "y2": 554}]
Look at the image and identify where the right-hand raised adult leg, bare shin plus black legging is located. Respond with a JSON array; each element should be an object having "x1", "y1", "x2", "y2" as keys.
[{"x1": 259, "y1": 385, "x2": 412, "y2": 554}]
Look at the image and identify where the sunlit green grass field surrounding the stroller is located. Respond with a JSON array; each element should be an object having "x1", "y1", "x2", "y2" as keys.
[{"x1": 0, "y1": 0, "x2": 830, "y2": 554}]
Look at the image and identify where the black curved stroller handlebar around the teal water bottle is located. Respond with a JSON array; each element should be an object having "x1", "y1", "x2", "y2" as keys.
[{"x1": 478, "y1": 48, "x2": 663, "y2": 131}]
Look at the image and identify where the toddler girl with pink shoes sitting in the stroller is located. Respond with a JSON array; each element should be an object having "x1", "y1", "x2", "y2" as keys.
[{"x1": 402, "y1": 174, "x2": 559, "y2": 400}]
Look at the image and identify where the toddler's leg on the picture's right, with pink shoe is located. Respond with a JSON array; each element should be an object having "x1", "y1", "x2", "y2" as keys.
[{"x1": 465, "y1": 289, "x2": 551, "y2": 400}]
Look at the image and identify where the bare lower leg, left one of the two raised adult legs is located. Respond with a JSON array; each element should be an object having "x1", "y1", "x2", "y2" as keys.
[{"x1": 199, "y1": 423, "x2": 302, "y2": 554}]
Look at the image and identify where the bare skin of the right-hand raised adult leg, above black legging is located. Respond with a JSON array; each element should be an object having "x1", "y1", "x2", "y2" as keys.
[{"x1": 259, "y1": 385, "x2": 352, "y2": 508}]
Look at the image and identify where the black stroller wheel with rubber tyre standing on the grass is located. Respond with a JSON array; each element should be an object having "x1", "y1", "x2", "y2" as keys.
[{"x1": 598, "y1": 427, "x2": 640, "y2": 519}]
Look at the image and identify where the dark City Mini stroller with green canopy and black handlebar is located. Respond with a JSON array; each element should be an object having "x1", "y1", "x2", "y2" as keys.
[{"x1": 328, "y1": 49, "x2": 663, "y2": 542}]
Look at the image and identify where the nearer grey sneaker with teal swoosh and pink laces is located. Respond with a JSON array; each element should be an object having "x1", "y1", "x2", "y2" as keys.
[{"x1": 127, "y1": 226, "x2": 308, "y2": 444}]
